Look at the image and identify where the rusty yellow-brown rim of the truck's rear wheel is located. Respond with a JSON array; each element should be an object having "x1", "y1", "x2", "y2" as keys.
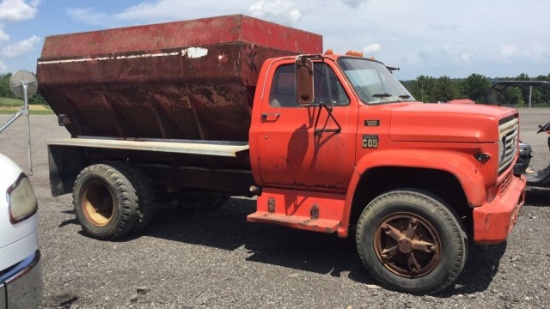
[{"x1": 82, "y1": 181, "x2": 115, "y2": 226}]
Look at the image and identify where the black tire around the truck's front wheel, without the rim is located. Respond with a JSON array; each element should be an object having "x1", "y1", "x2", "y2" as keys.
[{"x1": 356, "y1": 191, "x2": 467, "y2": 294}]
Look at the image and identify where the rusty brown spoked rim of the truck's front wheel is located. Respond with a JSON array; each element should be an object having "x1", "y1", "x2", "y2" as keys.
[{"x1": 374, "y1": 213, "x2": 441, "y2": 278}]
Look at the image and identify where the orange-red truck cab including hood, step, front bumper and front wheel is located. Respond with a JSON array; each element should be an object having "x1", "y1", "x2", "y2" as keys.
[{"x1": 248, "y1": 55, "x2": 525, "y2": 292}]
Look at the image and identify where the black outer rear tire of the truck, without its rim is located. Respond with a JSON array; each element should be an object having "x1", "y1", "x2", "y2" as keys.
[{"x1": 73, "y1": 164, "x2": 138, "y2": 239}]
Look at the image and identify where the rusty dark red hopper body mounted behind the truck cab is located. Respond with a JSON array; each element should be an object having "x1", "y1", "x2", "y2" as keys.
[{"x1": 37, "y1": 15, "x2": 322, "y2": 141}]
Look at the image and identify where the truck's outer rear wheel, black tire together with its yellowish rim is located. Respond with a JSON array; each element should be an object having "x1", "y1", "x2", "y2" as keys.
[{"x1": 73, "y1": 164, "x2": 139, "y2": 239}]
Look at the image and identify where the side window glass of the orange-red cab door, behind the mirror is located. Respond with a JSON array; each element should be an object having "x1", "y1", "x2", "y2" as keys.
[{"x1": 269, "y1": 63, "x2": 350, "y2": 107}]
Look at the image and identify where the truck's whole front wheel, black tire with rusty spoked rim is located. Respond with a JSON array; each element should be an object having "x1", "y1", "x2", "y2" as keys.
[{"x1": 356, "y1": 189, "x2": 468, "y2": 294}]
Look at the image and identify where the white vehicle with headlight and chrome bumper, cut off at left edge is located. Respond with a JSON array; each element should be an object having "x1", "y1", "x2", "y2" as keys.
[{"x1": 0, "y1": 154, "x2": 43, "y2": 309}]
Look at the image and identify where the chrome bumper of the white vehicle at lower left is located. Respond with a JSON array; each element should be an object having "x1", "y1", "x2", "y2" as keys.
[{"x1": 0, "y1": 250, "x2": 43, "y2": 309}]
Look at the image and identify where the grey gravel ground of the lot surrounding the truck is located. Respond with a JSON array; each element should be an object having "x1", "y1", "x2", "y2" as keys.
[{"x1": 0, "y1": 109, "x2": 550, "y2": 308}]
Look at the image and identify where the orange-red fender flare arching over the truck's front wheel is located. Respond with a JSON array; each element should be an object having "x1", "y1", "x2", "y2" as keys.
[{"x1": 338, "y1": 148, "x2": 487, "y2": 237}]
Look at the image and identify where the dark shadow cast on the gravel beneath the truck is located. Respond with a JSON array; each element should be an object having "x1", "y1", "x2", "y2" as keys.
[{"x1": 138, "y1": 198, "x2": 506, "y2": 297}]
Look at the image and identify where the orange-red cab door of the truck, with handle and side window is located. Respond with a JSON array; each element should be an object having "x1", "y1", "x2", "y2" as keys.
[{"x1": 255, "y1": 62, "x2": 357, "y2": 191}]
